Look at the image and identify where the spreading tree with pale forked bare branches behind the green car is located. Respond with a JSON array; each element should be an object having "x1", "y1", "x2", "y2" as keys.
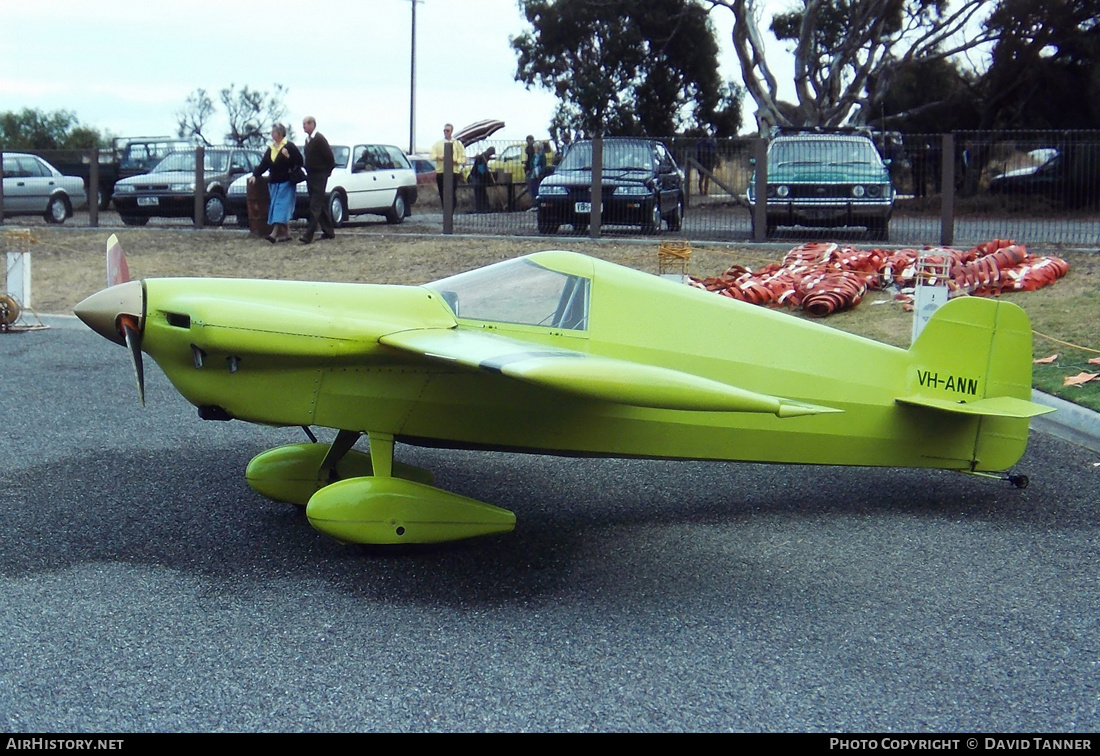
[{"x1": 702, "y1": 0, "x2": 997, "y2": 131}]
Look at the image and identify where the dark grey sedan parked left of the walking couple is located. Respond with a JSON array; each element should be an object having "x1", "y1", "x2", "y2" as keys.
[{"x1": 112, "y1": 147, "x2": 261, "y2": 226}]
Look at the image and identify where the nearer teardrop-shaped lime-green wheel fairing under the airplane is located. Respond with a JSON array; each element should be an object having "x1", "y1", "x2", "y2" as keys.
[{"x1": 306, "y1": 476, "x2": 516, "y2": 545}]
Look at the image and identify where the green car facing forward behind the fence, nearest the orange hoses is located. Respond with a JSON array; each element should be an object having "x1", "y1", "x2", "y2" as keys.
[{"x1": 748, "y1": 132, "x2": 894, "y2": 241}]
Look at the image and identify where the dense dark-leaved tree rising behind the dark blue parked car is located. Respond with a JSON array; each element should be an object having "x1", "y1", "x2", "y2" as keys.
[{"x1": 512, "y1": 0, "x2": 741, "y2": 136}]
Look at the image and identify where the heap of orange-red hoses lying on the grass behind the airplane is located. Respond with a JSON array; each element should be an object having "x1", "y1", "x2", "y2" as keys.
[{"x1": 692, "y1": 239, "x2": 1069, "y2": 317}]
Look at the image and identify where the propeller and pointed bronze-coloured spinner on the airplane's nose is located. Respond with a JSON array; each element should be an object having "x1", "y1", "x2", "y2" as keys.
[{"x1": 73, "y1": 233, "x2": 145, "y2": 405}]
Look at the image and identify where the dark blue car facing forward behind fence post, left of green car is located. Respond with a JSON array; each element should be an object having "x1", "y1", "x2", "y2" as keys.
[{"x1": 535, "y1": 136, "x2": 684, "y2": 233}]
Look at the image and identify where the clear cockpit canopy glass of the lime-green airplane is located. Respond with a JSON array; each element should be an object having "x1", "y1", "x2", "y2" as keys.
[{"x1": 428, "y1": 258, "x2": 590, "y2": 330}]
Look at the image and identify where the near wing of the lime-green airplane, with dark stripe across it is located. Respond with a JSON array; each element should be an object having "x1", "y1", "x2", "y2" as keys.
[{"x1": 381, "y1": 328, "x2": 842, "y2": 417}]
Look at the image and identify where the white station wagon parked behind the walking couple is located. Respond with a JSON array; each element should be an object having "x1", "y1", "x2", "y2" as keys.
[{"x1": 228, "y1": 144, "x2": 417, "y2": 226}]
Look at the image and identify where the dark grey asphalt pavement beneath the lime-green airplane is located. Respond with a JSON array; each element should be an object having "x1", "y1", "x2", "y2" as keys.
[{"x1": 0, "y1": 318, "x2": 1100, "y2": 733}]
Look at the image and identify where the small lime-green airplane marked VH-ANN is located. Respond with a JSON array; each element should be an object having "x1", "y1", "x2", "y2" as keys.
[{"x1": 76, "y1": 235, "x2": 1049, "y2": 544}]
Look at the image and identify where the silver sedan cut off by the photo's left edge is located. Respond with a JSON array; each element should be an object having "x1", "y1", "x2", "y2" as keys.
[{"x1": 3, "y1": 152, "x2": 86, "y2": 223}]
